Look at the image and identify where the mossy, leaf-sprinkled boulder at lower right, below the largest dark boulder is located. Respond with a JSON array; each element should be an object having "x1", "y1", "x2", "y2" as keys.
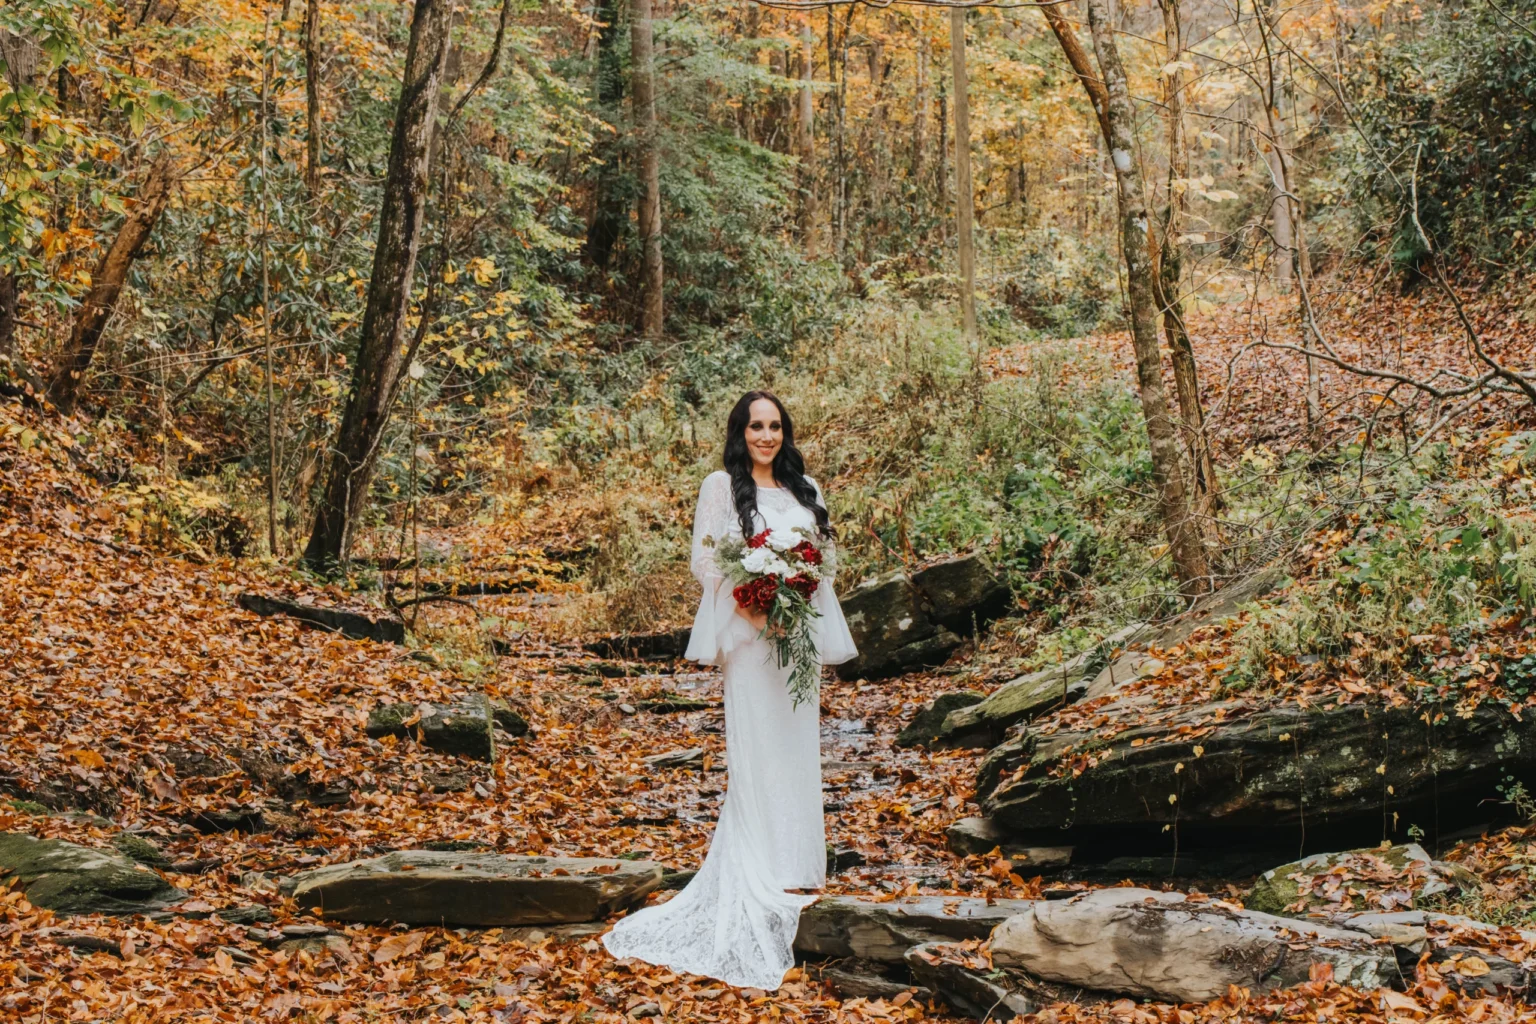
[{"x1": 1243, "y1": 843, "x2": 1475, "y2": 917}]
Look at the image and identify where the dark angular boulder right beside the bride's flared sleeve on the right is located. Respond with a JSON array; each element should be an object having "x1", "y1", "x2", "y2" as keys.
[{"x1": 837, "y1": 573, "x2": 960, "y2": 679}]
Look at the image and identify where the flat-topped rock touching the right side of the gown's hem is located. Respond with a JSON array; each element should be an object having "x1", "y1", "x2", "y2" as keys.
[{"x1": 794, "y1": 897, "x2": 1032, "y2": 964}]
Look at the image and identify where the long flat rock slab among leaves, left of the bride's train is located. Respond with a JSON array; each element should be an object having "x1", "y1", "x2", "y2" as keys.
[{"x1": 283, "y1": 851, "x2": 662, "y2": 927}]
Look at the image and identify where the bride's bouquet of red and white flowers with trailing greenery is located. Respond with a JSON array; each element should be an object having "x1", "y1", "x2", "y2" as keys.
[{"x1": 716, "y1": 530, "x2": 823, "y2": 708}]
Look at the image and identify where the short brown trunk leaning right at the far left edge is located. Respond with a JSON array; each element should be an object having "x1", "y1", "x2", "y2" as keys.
[{"x1": 48, "y1": 154, "x2": 178, "y2": 415}]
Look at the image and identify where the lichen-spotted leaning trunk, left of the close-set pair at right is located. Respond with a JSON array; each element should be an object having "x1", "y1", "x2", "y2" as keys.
[{"x1": 1087, "y1": 0, "x2": 1210, "y2": 596}]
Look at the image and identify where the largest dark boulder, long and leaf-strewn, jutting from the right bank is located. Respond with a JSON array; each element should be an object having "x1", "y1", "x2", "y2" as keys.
[{"x1": 977, "y1": 695, "x2": 1536, "y2": 854}]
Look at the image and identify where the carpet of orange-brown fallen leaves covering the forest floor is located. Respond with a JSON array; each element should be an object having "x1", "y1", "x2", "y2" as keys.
[{"x1": 0, "y1": 290, "x2": 1536, "y2": 1024}]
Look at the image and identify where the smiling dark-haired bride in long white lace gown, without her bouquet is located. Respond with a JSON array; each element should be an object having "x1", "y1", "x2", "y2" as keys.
[{"x1": 602, "y1": 391, "x2": 857, "y2": 990}]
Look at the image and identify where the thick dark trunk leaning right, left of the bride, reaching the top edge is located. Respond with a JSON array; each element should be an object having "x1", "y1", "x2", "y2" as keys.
[{"x1": 304, "y1": 0, "x2": 453, "y2": 568}]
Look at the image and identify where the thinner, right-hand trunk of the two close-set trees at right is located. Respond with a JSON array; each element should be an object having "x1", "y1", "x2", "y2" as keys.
[{"x1": 1157, "y1": 0, "x2": 1218, "y2": 528}]
